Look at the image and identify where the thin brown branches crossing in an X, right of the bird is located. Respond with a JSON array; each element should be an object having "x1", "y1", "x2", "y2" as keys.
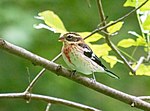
[{"x1": 84, "y1": 0, "x2": 148, "y2": 75}]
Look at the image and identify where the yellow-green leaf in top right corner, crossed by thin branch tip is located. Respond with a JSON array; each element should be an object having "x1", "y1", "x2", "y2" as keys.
[{"x1": 123, "y1": 0, "x2": 150, "y2": 11}]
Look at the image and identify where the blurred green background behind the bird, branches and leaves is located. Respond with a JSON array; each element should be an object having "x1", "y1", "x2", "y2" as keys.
[{"x1": 0, "y1": 0, "x2": 150, "y2": 111}]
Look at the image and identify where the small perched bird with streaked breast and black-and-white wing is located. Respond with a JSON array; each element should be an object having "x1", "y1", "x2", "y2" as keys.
[{"x1": 59, "y1": 32, "x2": 119, "y2": 79}]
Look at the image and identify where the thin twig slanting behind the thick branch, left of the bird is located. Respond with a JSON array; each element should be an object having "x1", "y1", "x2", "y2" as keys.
[{"x1": 25, "y1": 53, "x2": 62, "y2": 93}]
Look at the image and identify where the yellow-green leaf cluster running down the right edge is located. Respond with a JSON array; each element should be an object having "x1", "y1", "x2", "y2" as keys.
[{"x1": 122, "y1": 0, "x2": 150, "y2": 76}]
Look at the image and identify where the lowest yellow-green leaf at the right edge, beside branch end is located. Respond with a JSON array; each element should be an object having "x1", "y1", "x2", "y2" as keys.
[{"x1": 130, "y1": 64, "x2": 150, "y2": 76}]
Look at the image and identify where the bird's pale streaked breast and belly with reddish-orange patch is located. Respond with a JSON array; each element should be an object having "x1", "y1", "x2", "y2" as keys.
[{"x1": 62, "y1": 47, "x2": 104, "y2": 75}]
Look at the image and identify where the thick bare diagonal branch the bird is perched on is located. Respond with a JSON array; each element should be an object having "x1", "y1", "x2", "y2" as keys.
[{"x1": 0, "y1": 39, "x2": 150, "y2": 110}]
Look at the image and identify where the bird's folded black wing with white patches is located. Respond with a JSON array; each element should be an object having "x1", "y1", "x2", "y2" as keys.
[{"x1": 78, "y1": 43, "x2": 106, "y2": 69}]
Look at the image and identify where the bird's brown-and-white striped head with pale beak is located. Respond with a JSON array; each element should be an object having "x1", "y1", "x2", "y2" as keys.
[{"x1": 59, "y1": 32, "x2": 83, "y2": 43}]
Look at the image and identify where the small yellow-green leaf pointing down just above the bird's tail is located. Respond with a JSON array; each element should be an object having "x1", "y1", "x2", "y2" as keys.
[{"x1": 102, "y1": 55, "x2": 118, "y2": 68}]
